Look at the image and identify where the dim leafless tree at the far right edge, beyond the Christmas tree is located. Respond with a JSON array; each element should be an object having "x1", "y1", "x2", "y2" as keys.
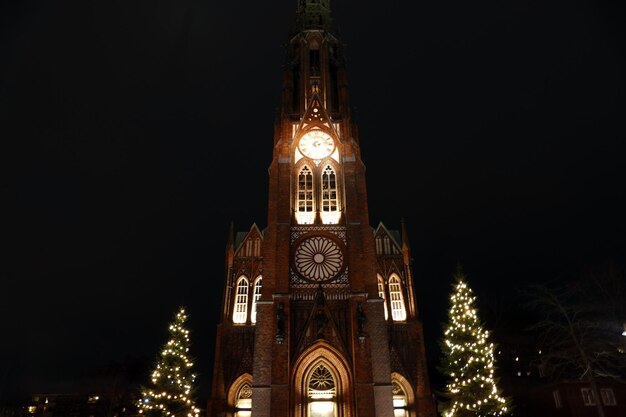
[{"x1": 524, "y1": 262, "x2": 626, "y2": 417}]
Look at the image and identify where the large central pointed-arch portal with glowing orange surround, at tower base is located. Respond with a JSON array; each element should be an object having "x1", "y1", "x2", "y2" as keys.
[{"x1": 292, "y1": 342, "x2": 354, "y2": 417}]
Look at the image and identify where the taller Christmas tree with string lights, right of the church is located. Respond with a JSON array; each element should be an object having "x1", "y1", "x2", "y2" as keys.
[{"x1": 439, "y1": 269, "x2": 511, "y2": 417}]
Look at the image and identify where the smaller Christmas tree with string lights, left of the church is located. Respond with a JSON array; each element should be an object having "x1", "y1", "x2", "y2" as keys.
[{"x1": 138, "y1": 307, "x2": 200, "y2": 417}]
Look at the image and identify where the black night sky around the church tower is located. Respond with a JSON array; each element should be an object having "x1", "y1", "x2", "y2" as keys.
[{"x1": 0, "y1": 0, "x2": 626, "y2": 403}]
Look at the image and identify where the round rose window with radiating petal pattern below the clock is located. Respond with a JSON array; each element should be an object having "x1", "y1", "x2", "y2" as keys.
[{"x1": 294, "y1": 236, "x2": 343, "y2": 282}]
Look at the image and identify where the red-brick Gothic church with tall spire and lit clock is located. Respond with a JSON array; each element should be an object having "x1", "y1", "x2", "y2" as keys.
[{"x1": 208, "y1": 0, "x2": 436, "y2": 417}]
